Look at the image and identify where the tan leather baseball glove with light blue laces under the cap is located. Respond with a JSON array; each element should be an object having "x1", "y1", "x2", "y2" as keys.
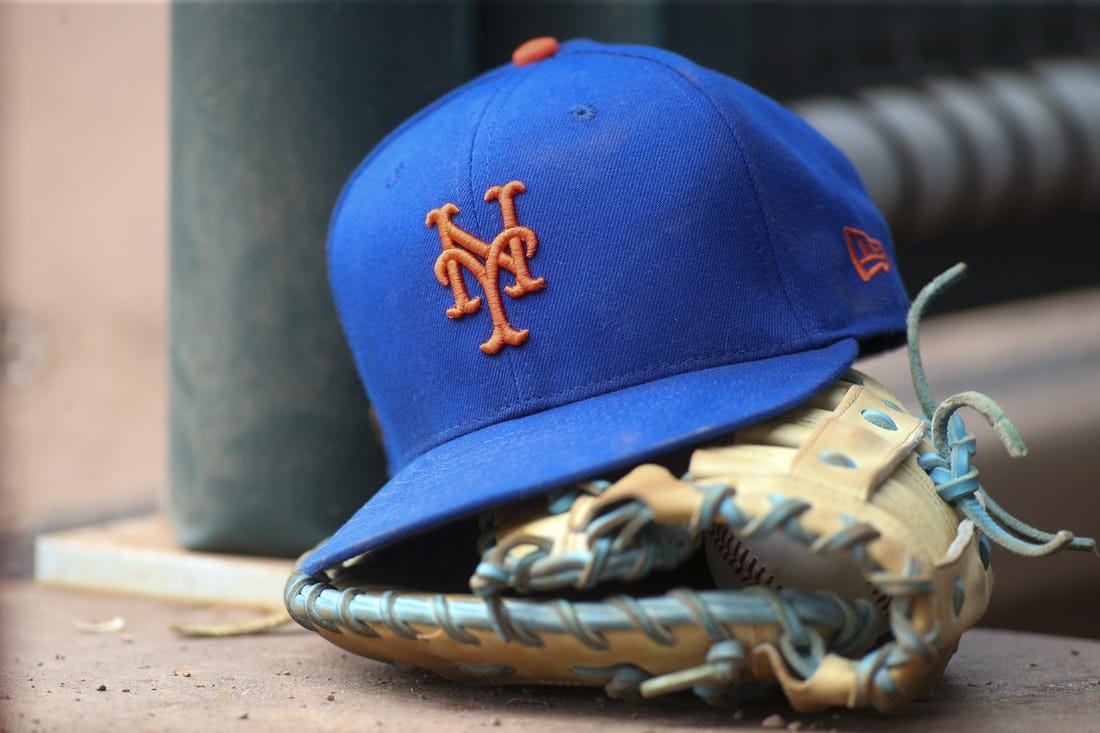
[{"x1": 286, "y1": 266, "x2": 1095, "y2": 712}]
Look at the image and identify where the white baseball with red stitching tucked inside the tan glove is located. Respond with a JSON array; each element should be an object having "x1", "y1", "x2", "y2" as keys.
[{"x1": 703, "y1": 525, "x2": 891, "y2": 613}]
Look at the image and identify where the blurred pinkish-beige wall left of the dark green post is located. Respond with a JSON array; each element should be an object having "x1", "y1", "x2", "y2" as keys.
[{"x1": 0, "y1": 0, "x2": 168, "y2": 535}]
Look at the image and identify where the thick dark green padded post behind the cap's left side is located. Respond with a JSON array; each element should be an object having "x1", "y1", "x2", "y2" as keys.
[{"x1": 166, "y1": 1, "x2": 473, "y2": 557}]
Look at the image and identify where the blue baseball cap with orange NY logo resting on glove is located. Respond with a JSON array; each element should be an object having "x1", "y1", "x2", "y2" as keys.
[{"x1": 303, "y1": 39, "x2": 909, "y2": 572}]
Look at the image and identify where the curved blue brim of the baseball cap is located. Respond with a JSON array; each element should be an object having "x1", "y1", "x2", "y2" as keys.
[{"x1": 301, "y1": 339, "x2": 858, "y2": 573}]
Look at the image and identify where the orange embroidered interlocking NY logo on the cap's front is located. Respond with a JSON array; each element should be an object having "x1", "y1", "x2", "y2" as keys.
[{"x1": 425, "y1": 180, "x2": 547, "y2": 354}]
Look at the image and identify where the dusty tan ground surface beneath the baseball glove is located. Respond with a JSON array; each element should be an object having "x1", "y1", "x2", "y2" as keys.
[{"x1": 0, "y1": 580, "x2": 1100, "y2": 733}]
